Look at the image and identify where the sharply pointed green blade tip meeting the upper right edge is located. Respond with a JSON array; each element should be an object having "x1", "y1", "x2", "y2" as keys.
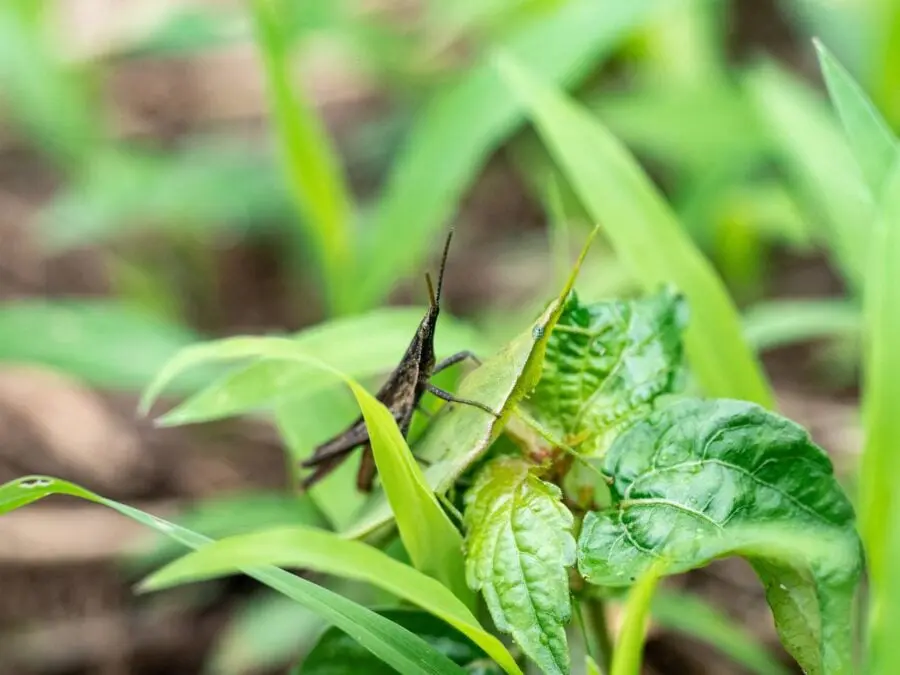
[{"x1": 813, "y1": 40, "x2": 900, "y2": 198}]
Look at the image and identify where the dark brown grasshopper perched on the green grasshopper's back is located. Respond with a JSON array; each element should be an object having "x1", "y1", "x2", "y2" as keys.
[{"x1": 301, "y1": 230, "x2": 498, "y2": 492}]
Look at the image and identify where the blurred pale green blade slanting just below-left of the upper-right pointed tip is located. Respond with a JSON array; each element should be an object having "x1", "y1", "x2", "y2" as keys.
[{"x1": 745, "y1": 64, "x2": 873, "y2": 289}]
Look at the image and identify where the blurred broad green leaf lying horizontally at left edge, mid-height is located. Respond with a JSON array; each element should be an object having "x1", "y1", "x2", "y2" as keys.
[{"x1": 0, "y1": 300, "x2": 205, "y2": 391}]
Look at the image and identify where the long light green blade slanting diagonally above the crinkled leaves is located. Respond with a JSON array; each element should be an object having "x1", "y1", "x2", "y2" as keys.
[{"x1": 496, "y1": 54, "x2": 772, "y2": 407}]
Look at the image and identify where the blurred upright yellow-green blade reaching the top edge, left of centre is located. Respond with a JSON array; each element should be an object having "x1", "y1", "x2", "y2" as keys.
[{"x1": 250, "y1": 0, "x2": 354, "y2": 311}]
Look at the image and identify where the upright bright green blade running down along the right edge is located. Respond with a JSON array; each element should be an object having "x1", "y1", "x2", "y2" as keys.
[{"x1": 859, "y1": 161, "x2": 900, "y2": 593}]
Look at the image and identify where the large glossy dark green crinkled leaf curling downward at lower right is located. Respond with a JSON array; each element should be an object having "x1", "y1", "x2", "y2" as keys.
[{"x1": 578, "y1": 399, "x2": 861, "y2": 674}]
